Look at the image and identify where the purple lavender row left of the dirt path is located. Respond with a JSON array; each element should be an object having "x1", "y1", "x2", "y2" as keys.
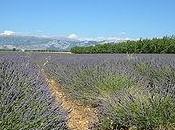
[{"x1": 0, "y1": 55, "x2": 67, "y2": 130}]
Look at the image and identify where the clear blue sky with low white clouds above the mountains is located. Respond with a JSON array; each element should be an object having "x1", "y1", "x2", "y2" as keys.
[{"x1": 0, "y1": 0, "x2": 175, "y2": 39}]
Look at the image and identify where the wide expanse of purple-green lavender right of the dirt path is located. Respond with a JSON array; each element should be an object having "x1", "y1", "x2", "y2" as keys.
[{"x1": 39, "y1": 54, "x2": 175, "y2": 130}]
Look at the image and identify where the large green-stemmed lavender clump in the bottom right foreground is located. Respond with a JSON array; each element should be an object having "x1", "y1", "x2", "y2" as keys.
[{"x1": 100, "y1": 87, "x2": 175, "y2": 130}]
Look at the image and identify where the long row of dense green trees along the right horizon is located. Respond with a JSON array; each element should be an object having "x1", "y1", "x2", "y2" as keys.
[{"x1": 71, "y1": 36, "x2": 175, "y2": 54}]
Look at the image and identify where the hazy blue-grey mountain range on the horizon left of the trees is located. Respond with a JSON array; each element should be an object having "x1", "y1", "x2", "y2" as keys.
[{"x1": 0, "y1": 35, "x2": 121, "y2": 51}]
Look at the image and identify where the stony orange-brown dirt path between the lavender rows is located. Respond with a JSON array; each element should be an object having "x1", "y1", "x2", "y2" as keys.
[{"x1": 47, "y1": 79, "x2": 98, "y2": 130}]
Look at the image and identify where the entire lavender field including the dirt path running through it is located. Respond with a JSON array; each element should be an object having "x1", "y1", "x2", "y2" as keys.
[{"x1": 0, "y1": 52, "x2": 175, "y2": 130}]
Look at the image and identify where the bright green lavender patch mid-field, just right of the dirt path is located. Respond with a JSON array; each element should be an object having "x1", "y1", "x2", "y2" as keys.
[{"x1": 55, "y1": 67, "x2": 135, "y2": 105}]
